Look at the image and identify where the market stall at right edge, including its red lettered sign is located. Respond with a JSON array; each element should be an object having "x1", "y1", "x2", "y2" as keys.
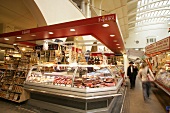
[{"x1": 146, "y1": 37, "x2": 170, "y2": 95}]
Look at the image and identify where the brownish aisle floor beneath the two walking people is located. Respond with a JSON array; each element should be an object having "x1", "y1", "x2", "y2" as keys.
[{"x1": 123, "y1": 79, "x2": 166, "y2": 113}]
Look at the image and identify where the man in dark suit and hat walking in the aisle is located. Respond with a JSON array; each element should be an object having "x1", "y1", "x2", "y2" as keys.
[{"x1": 127, "y1": 62, "x2": 136, "y2": 89}]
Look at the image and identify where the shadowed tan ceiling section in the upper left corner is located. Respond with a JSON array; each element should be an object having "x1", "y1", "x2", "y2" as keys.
[{"x1": 0, "y1": 0, "x2": 37, "y2": 32}]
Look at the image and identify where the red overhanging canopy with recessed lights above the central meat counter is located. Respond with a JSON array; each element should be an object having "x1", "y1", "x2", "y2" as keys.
[{"x1": 0, "y1": 14, "x2": 125, "y2": 54}]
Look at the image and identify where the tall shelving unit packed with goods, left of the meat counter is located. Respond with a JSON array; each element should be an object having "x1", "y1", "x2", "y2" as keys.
[{"x1": 0, "y1": 52, "x2": 29, "y2": 103}]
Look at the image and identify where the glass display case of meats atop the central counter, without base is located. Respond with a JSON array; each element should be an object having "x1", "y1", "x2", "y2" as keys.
[{"x1": 25, "y1": 64, "x2": 122, "y2": 97}]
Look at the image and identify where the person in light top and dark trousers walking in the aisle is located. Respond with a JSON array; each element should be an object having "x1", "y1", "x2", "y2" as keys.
[{"x1": 138, "y1": 62, "x2": 154, "y2": 101}]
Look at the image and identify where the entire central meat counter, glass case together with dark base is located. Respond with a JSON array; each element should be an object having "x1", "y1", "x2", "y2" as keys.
[{"x1": 24, "y1": 64, "x2": 123, "y2": 112}]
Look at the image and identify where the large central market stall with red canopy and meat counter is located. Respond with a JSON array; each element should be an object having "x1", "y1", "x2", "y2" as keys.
[{"x1": 0, "y1": 14, "x2": 125, "y2": 113}]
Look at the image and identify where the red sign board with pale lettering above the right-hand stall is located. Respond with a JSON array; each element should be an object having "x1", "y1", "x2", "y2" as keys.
[{"x1": 145, "y1": 37, "x2": 170, "y2": 54}]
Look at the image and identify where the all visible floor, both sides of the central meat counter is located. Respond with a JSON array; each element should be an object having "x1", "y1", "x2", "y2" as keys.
[{"x1": 0, "y1": 80, "x2": 170, "y2": 113}]
